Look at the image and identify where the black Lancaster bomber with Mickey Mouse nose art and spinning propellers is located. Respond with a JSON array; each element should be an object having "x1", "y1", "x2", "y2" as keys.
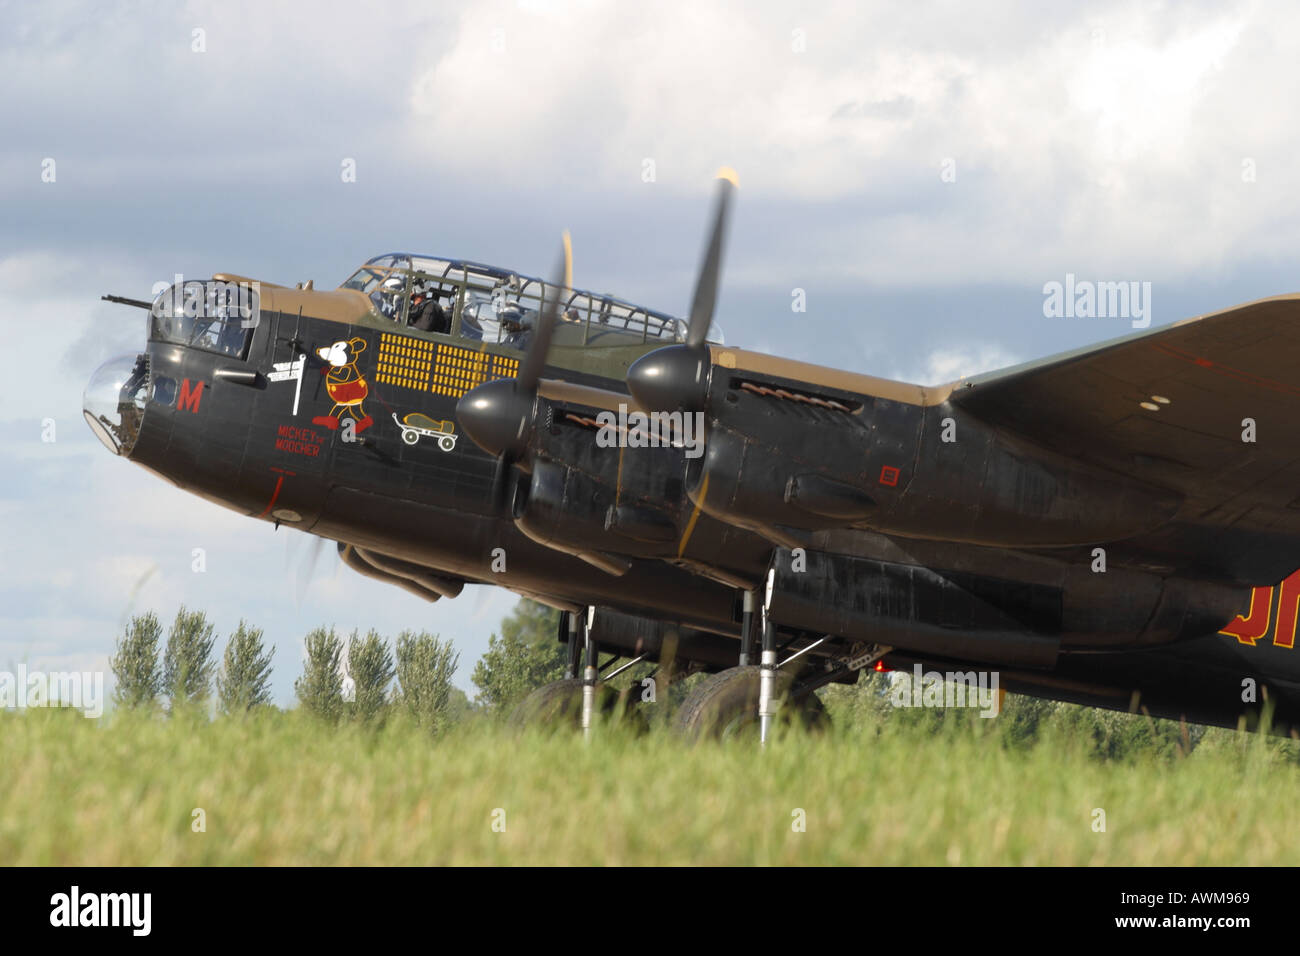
[{"x1": 94, "y1": 170, "x2": 1300, "y2": 734}]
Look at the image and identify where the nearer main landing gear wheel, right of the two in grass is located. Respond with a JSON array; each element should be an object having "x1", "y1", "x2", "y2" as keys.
[{"x1": 673, "y1": 665, "x2": 831, "y2": 740}]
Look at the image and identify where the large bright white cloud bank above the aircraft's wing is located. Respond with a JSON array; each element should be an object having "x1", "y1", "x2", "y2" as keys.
[{"x1": 411, "y1": 0, "x2": 1300, "y2": 285}]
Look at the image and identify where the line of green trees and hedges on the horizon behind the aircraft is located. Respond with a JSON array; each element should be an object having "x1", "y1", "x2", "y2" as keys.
[{"x1": 112, "y1": 598, "x2": 1242, "y2": 758}]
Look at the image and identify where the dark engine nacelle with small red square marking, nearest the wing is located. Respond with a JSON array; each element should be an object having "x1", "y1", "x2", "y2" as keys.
[{"x1": 686, "y1": 369, "x2": 1180, "y2": 548}]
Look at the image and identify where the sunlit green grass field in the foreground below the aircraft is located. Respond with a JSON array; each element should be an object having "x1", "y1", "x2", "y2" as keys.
[{"x1": 0, "y1": 710, "x2": 1300, "y2": 865}]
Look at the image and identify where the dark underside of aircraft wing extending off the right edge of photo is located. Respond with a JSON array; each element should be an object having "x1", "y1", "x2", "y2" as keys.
[{"x1": 950, "y1": 294, "x2": 1300, "y2": 575}]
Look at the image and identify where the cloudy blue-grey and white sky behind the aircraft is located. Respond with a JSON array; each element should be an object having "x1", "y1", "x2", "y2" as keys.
[{"x1": 0, "y1": 0, "x2": 1300, "y2": 704}]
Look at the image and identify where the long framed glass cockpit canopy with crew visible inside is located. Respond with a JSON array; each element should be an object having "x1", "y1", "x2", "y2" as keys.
[{"x1": 339, "y1": 252, "x2": 722, "y2": 345}]
